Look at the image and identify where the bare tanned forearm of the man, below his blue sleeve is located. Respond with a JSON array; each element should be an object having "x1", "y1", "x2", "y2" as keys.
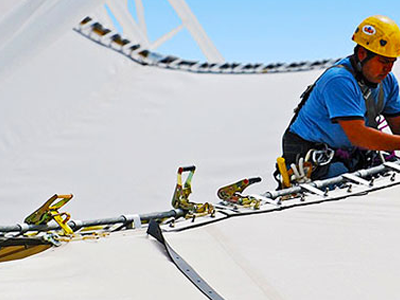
[{"x1": 338, "y1": 117, "x2": 400, "y2": 151}]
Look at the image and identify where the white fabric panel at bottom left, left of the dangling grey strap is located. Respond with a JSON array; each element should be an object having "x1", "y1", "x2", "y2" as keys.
[{"x1": 0, "y1": 231, "x2": 204, "y2": 300}]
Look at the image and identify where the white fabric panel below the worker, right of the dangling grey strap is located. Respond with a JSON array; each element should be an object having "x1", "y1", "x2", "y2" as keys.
[{"x1": 166, "y1": 187, "x2": 400, "y2": 300}]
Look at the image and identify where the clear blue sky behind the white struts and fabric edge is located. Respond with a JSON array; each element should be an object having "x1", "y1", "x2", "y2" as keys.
[{"x1": 108, "y1": 0, "x2": 400, "y2": 63}]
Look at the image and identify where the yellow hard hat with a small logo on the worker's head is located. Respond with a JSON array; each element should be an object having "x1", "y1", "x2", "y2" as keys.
[{"x1": 352, "y1": 15, "x2": 400, "y2": 58}]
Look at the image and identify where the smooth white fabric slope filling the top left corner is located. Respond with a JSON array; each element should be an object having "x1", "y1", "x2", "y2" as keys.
[{"x1": 0, "y1": 0, "x2": 105, "y2": 79}]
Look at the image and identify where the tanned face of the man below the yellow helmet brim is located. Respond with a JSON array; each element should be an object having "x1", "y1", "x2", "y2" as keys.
[{"x1": 362, "y1": 55, "x2": 396, "y2": 83}]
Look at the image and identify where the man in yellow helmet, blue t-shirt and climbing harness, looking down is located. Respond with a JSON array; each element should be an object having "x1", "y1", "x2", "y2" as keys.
[{"x1": 280, "y1": 15, "x2": 400, "y2": 186}]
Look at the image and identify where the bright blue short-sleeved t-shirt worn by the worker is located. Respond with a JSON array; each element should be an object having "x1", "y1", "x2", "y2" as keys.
[{"x1": 290, "y1": 58, "x2": 400, "y2": 149}]
